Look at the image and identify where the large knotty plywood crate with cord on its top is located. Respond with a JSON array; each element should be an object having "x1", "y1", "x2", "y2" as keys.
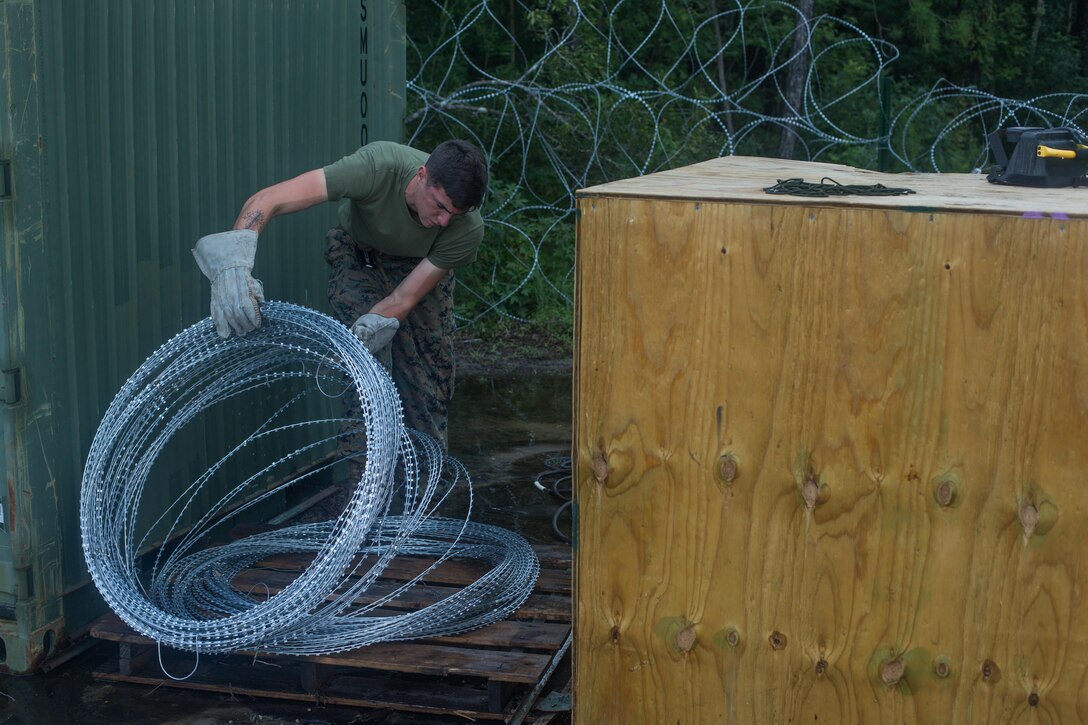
[{"x1": 574, "y1": 157, "x2": 1088, "y2": 723}]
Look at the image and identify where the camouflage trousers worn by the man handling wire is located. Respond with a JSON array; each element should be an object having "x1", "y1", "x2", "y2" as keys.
[{"x1": 325, "y1": 226, "x2": 454, "y2": 454}]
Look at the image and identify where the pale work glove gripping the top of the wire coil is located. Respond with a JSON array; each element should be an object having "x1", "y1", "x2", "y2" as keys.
[{"x1": 193, "y1": 229, "x2": 264, "y2": 337}]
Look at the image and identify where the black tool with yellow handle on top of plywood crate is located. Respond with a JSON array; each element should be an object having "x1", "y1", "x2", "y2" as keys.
[{"x1": 987, "y1": 126, "x2": 1088, "y2": 188}]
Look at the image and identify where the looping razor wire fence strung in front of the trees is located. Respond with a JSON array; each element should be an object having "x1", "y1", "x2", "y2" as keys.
[{"x1": 407, "y1": 0, "x2": 1088, "y2": 327}]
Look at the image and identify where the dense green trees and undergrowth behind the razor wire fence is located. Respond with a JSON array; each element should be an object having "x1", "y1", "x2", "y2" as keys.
[{"x1": 406, "y1": 0, "x2": 1088, "y2": 327}]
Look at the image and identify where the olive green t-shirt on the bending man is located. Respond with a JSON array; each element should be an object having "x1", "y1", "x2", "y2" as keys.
[{"x1": 324, "y1": 142, "x2": 483, "y2": 269}]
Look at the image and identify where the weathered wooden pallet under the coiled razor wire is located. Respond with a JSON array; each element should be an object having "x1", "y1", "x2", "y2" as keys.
[{"x1": 91, "y1": 539, "x2": 571, "y2": 722}]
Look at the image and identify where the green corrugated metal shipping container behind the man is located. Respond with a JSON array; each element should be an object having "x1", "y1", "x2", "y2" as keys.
[{"x1": 0, "y1": 0, "x2": 405, "y2": 672}]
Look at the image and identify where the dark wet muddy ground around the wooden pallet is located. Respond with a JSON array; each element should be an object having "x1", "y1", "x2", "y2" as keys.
[{"x1": 0, "y1": 372, "x2": 571, "y2": 725}]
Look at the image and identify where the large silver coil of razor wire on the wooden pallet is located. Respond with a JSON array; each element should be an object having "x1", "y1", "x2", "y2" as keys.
[{"x1": 79, "y1": 303, "x2": 540, "y2": 654}]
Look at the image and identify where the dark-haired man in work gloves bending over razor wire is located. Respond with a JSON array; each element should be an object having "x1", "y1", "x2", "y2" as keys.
[{"x1": 193, "y1": 140, "x2": 487, "y2": 451}]
